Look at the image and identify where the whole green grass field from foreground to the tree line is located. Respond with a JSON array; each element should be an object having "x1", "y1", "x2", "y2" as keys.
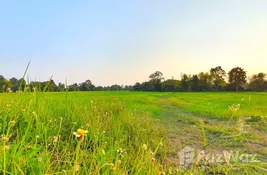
[{"x1": 0, "y1": 92, "x2": 267, "y2": 174}]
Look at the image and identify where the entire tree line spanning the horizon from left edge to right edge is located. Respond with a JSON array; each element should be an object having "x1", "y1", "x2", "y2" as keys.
[{"x1": 0, "y1": 66, "x2": 267, "y2": 92}]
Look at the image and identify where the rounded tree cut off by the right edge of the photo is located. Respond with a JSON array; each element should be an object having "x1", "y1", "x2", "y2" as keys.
[{"x1": 249, "y1": 72, "x2": 267, "y2": 91}]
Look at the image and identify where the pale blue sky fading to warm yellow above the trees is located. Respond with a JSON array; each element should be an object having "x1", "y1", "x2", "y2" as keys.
[{"x1": 0, "y1": 0, "x2": 267, "y2": 86}]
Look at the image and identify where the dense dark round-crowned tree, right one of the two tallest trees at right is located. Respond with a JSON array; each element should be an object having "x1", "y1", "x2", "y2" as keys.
[{"x1": 228, "y1": 67, "x2": 247, "y2": 91}]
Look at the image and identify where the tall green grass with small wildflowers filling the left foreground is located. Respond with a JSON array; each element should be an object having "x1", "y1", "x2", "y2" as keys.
[{"x1": 0, "y1": 91, "x2": 166, "y2": 174}]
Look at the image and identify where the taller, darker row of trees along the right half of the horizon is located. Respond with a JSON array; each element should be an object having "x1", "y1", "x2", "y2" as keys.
[{"x1": 133, "y1": 66, "x2": 267, "y2": 92}]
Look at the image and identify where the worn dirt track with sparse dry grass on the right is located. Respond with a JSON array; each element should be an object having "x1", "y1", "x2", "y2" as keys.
[{"x1": 158, "y1": 99, "x2": 267, "y2": 166}]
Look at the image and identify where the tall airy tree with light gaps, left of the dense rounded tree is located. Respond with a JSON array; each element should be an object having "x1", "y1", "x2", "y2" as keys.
[{"x1": 210, "y1": 66, "x2": 226, "y2": 91}]
